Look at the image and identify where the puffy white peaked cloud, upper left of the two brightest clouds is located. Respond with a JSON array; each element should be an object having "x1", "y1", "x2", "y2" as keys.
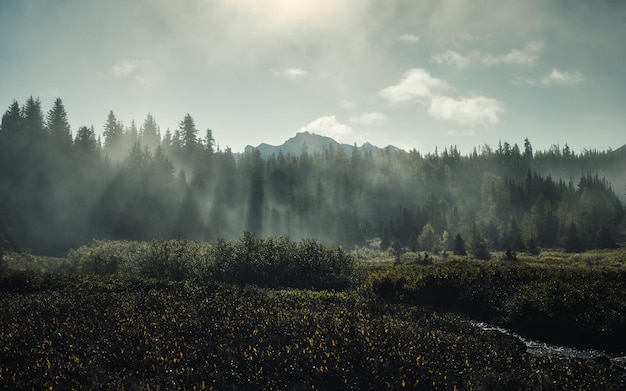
[{"x1": 378, "y1": 68, "x2": 449, "y2": 103}]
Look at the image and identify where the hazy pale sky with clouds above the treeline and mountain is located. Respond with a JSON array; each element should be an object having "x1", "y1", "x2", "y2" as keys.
[{"x1": 0, "y1": 0, "x2": 626, "y2": 153}]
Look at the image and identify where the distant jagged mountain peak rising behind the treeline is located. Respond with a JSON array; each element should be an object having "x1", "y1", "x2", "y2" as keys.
[{"x1": 245, "y1": 132, "x2": 399, "y2": 158}]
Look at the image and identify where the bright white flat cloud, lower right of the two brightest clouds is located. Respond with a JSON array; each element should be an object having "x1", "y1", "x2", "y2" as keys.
[{"x1": 428, "y1": 96, "x2": 504, "y2": 126}]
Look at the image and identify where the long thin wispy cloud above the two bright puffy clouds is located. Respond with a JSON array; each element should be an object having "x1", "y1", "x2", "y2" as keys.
[{"x1": 431, "y1": 41, "x2": 543, "y2": 68}]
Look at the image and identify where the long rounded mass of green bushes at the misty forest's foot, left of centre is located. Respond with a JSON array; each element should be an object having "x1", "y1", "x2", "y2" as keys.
[{"x1": 68, "y1": 233, "x2": 359, "y2": 290}]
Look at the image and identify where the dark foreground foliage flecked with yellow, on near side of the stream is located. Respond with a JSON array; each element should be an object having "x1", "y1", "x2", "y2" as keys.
[{"x1": 0, "y1": 273, "x2": 626, "y2": 390}]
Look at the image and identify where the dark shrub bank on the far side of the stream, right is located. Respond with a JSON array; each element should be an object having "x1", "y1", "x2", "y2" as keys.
[{"x1": 372, "y1": 261, "x2": 626, "y2": 353}]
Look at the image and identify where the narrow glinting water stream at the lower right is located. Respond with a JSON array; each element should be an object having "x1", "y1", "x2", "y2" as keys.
[{"x1": 471, "y1": 321, "x2": 626, "y2": 371}]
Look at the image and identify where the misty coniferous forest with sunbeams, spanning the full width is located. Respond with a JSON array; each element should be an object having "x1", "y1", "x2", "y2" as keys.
[{"x1": 0, "y1": 97, "x2": 626, "y2": 258}]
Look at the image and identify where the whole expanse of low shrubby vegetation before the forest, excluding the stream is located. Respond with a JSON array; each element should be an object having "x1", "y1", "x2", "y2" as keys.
[{"x1": 0, "y1": 239, "x2": 626, "y2": 390}]
